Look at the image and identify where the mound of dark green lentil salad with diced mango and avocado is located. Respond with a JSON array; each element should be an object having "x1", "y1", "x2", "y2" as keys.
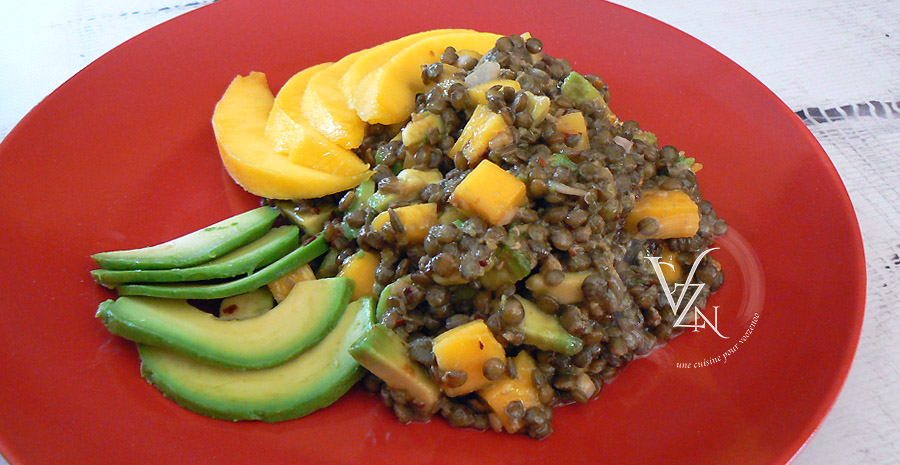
[{"x1": 273, "y1": 35, "x2": 727, "y2": 438}]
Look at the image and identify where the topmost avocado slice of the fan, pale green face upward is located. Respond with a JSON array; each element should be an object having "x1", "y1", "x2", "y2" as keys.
[{"x1": 91, "y1": 207, "x2": 278, "y2": 270}]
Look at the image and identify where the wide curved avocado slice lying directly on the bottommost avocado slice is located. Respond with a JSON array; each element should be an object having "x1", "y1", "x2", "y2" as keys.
[{"x1": 97, "y1": 278, "x2": 353, "y2": 368}]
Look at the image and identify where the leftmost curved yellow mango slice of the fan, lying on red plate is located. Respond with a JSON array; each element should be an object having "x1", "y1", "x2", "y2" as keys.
[{"x1": 212, "y1": 72, "x2": 371, "y2": 199}]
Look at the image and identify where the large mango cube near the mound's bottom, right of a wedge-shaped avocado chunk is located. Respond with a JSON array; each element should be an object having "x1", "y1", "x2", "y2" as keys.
[{"x1": 432, "y1": 320, "x2": 506, "y2": 397}]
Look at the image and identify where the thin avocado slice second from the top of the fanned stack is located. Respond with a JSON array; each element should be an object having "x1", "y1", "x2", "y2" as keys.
[{"x1": 91, "y1": 226, "x2": 300, "y2": 288}]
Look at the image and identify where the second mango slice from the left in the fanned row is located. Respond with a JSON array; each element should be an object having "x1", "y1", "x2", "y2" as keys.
[{"x1": 266, "y1": 63, "x2": 369, "y2": 176}]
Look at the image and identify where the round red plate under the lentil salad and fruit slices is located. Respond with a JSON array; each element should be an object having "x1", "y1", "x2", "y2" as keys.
[{"x1": 0, "y1": 0, "x2": 865, "y2": 465}]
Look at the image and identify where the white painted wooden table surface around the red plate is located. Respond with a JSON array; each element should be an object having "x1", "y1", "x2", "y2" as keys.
[{"x1": 0, "y1": 0, "x2": 900, "y2": 465}]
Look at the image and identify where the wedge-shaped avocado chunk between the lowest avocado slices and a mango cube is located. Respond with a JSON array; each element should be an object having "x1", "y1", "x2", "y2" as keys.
[{"x1": 349, "y1": 324, "x2": 441, "y2": 413}]
